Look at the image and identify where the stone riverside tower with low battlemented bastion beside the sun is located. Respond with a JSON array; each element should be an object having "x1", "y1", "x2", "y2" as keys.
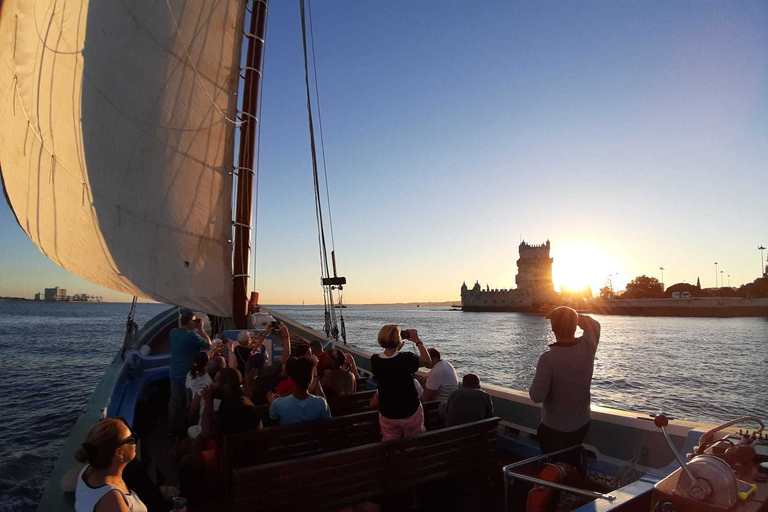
[{"x1": 461, "y1": 240, "x2": 556, "y2": 311}]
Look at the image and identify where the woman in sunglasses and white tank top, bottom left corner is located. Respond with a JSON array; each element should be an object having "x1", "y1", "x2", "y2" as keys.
[{"x1": 75, "y1": 418, "x2": 147, "y2": 512}]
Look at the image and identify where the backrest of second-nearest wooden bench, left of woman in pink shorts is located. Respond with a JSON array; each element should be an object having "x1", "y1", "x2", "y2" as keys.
[{"x1": 224, "y1": 411, "x2": 381, "y2": 469}]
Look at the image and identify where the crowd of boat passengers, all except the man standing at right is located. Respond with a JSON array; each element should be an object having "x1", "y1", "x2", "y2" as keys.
[{"x1": 76, "y1": 314, "x2": 516, "y2": 512}]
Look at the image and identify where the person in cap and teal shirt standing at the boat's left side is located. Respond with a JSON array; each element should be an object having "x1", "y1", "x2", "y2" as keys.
[{"x1": 168, "y1": 313, "x2": 211, "y2": 434}]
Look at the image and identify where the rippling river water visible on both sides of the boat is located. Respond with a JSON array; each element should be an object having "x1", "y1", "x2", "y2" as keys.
[{"x1": 0, "y1": 302, "x2": 768, "y2": 512}]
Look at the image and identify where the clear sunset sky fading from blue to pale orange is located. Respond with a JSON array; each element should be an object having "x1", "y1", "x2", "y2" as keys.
[{"x1": 0, "y1": 0, "x2": 768, "y2": 304}]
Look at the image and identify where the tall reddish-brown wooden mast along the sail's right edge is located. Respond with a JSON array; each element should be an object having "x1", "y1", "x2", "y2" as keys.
[{"x1": 232, "y1": 0, "x2": 267, "y2": 329}]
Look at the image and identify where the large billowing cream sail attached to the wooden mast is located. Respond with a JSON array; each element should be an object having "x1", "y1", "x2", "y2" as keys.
[{"x1": 0, "y1": 0, "x2": 244, "y2": 316}]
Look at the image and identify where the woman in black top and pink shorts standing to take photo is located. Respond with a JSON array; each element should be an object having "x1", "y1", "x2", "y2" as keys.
[{"x1": 371, "y1": 325, "x2": 432, "y2": 441}]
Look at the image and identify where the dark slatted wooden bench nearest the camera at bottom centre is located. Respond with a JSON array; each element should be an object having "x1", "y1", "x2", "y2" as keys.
[{"x1": 227, "y1": 418, "x2": 500, "y2": 512}]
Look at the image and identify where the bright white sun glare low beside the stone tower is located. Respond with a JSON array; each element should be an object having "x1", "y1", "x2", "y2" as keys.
[{"x1": 552, "y1": 245, "x2": 622, "y2": 294}]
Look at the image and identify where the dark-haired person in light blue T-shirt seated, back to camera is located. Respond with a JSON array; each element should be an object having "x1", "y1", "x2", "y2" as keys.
[{"x1": 267, "y1": 356, "x2": 331, "y2": 425}]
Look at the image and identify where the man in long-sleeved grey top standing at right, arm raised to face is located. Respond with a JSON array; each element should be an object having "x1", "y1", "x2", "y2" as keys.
[{"x1": 529, "y1": 307, "x2": 600, "y2": 453}]
